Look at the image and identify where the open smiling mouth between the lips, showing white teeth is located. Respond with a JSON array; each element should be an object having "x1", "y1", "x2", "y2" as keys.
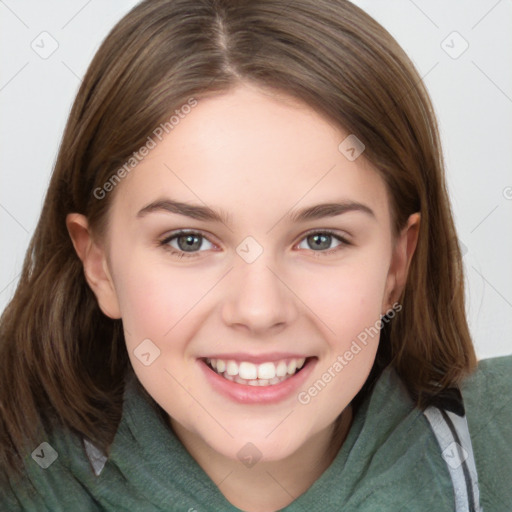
[{"x1": 204, "y1": 357, "x2": 315, "y2": 386}]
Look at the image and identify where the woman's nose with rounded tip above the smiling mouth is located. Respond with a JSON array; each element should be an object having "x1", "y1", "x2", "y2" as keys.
[{"x1": 222, "y1": 252, "x2": 298, "y2": 336}]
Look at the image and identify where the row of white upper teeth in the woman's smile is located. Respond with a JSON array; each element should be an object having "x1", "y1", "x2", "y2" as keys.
[{"x1": 207, "y1": 357, "x2": 306, "y2": 380}]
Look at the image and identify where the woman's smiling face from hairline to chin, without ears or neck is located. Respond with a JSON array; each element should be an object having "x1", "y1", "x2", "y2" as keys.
[{"x1": 86, "y1": 86, "x2": 404, "y2": 460}]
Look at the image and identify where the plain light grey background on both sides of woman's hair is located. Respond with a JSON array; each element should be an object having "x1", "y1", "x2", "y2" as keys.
[{"x1": 0, "y1": 0, "x2": 512, "y2": 358}]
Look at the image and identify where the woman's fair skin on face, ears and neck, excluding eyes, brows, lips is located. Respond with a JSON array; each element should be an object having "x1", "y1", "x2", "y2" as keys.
[{"x1": 67, "y1": 84, "x2": 419, "y2": 512}]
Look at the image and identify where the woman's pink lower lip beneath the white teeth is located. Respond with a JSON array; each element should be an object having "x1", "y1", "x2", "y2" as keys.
[{"x1": 198, "y1": 358, "x2": 317, "y2": 404}]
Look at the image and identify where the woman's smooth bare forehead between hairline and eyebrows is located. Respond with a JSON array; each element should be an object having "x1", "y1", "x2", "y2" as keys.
[{"x1": 115, "y1": 86, "x2": 388, "y2": 225}]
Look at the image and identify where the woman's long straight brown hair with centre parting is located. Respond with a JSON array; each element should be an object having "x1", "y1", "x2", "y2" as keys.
[{"x1": 0, "y1": 0, "x2": 476, "y2": 482}]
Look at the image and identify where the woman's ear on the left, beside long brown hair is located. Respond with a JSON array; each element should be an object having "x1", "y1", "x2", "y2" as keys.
[{"x1": 66, "y1": 213, "x2": 121, "y2": 319}]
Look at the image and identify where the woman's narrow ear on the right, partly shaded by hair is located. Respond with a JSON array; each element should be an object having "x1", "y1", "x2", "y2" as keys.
[{"x1": 382, "y1": 212, "x2": 420, "y2": 314}]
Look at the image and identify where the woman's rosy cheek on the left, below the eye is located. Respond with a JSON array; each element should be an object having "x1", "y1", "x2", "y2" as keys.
[{"x1": 112, "y1": 251, "x2": 208, "y2": 396}]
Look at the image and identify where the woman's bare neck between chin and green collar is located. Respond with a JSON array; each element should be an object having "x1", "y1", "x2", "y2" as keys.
[{"x1": 170, "y1": 405, "x2": 352, "y2": 512}]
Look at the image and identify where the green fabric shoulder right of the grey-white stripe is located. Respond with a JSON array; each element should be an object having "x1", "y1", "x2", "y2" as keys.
[{"x1": 461, "y1": 355, "x2": 512, "y2": 510}]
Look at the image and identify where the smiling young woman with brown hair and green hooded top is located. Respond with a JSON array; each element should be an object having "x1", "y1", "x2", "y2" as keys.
[{"x1": 0, "y1": 0, "x2": 512, "y2": 512}]
